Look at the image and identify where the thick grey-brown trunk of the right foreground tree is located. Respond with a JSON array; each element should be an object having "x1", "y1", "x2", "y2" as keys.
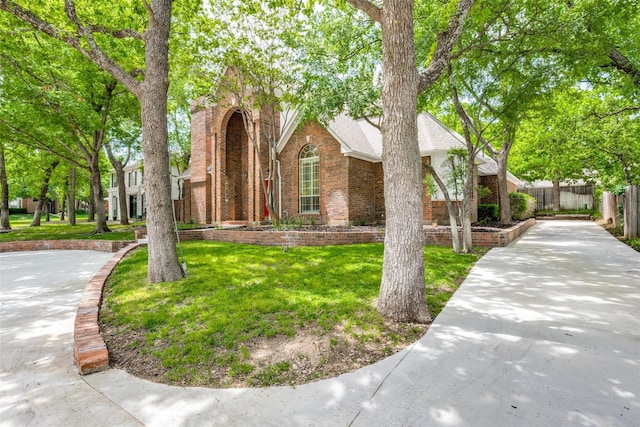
[{"x1": 378, "y1": 0, "x2": 431, "y2": 322}]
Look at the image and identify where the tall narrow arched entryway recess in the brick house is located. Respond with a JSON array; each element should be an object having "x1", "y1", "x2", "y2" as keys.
[{"x1": 222, "y1": 111, "x2": 249, "y2": 221}]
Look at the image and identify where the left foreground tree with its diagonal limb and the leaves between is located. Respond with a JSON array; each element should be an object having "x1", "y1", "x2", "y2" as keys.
[{"x1": 0, "y1": 0, "x2": 195, "y2": 283}]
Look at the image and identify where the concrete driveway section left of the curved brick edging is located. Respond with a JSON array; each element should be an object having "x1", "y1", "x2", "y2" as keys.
[{"x1": 0, "y1": 251, "x2": 139, "y2": 426}]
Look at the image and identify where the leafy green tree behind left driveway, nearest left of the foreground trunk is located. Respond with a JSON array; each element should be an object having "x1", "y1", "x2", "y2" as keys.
[{"x1": 0, "y1": 33, "x2": 129, "y2": 233}]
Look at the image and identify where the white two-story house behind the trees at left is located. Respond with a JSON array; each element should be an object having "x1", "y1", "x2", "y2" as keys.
[{"x1": 107, "y1": 162, "x2": 180, "y2": 221}]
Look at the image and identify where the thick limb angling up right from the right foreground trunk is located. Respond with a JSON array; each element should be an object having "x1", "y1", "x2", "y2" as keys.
[{"x1": 420, "y1": 0, "x2": 474, "y2": 95}]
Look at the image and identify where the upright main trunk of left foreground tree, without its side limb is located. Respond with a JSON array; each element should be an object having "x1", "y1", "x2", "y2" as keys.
[{"x1": 140, "y1": 0, "x2": 183, "y2": 283}]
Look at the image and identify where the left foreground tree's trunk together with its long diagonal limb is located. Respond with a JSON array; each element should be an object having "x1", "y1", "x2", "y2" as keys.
[{"x1": 0, "y1": 0, "x2": 183, "y2": 283}]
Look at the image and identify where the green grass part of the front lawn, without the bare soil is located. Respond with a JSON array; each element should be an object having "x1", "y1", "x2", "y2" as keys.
[{"x1": 101, "y1": 242, "x2": 478, "y2": 386}]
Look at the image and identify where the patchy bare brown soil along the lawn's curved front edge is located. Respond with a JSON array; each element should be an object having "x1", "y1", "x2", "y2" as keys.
[{"x1": 102, "y1": 322, "x2": 428, "y2": 388}]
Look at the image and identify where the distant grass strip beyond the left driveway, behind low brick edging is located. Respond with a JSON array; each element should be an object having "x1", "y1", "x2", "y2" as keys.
[{"x1": 0, "y1": 215, "x2": 138, "y2": 242}]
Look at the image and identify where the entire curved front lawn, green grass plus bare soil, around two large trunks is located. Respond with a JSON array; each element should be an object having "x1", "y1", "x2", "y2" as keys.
[{"x1": 101, "y1": 242, "x2": 479, "y2": 387}]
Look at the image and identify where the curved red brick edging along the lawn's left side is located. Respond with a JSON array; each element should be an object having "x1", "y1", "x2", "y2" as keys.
[{"x1": 73, "y1": 243, "x2": 140, "y2": 375}]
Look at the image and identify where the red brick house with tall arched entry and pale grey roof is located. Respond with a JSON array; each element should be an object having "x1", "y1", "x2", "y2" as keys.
[{"x1": 179, "y1": 91, "x2": 515, "y2": 225}]
